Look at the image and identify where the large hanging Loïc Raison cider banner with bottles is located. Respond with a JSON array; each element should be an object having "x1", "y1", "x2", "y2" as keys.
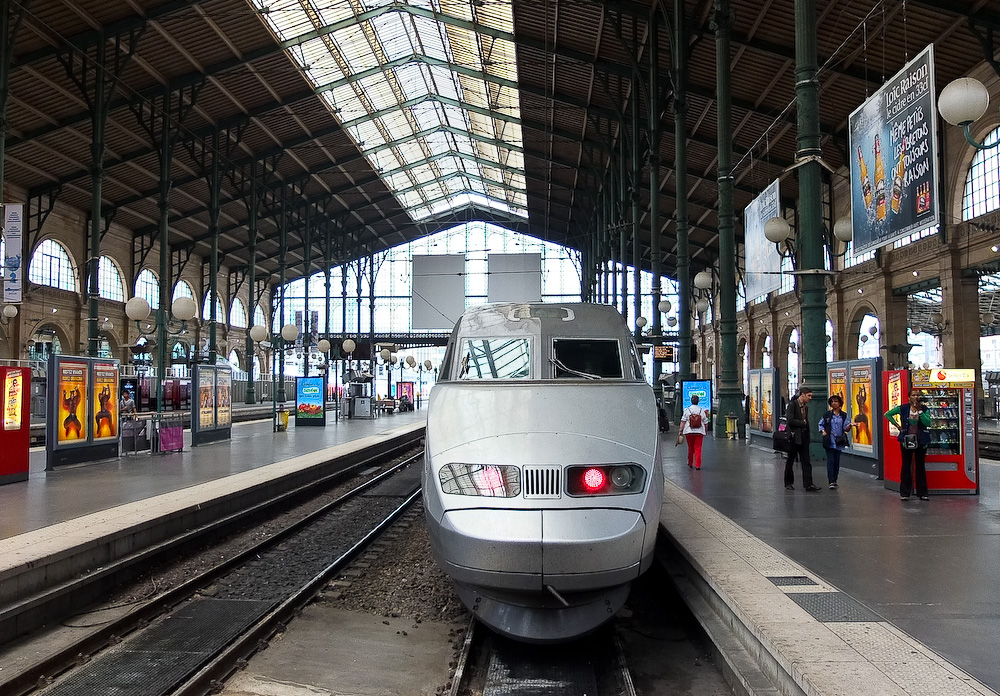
[{"x1": 849, "y1": 44, "x2": 938, "y2": 256}]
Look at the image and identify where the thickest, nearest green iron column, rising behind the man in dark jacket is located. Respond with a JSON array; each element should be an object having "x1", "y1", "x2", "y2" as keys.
[{"x1": 795, "y1": 0, "x2": 827, "y2": 457}]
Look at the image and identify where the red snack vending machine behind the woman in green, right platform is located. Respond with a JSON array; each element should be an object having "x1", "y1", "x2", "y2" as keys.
[{"x1": 881, "y1": 368, "x2": 979, "y2": 494}]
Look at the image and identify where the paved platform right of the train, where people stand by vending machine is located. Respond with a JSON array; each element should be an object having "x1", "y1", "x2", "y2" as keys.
[{"x1": 661, "y1": 432, "x2": 1000, "y2": 696}]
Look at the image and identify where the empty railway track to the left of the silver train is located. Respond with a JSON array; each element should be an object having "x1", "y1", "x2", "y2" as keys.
[{"x1": 0, "y1": 446, "x2": 422, "y2": 696}]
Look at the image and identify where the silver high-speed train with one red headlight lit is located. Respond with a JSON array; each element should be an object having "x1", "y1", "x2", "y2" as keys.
[{"x1": 423, "y1": 303, "x2": 663, "y2": 643}]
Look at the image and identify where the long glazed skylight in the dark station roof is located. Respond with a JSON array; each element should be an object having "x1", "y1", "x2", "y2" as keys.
[{"x1": 248, "y1": 0, "x2": 527, "y2": 221}]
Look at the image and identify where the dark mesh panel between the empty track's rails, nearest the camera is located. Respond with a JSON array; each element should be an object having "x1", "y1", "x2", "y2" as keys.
[{"x1": 42, "y1": 599, "x2": 274, "y2": 696}]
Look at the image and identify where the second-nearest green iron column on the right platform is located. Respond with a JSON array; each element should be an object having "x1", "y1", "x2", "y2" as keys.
[{"x1": 714, "y1": 0, "x2": 743, "y2": 438}]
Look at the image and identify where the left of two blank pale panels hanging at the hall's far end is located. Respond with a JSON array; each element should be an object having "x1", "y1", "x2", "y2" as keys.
[{"x1": 411, "y1": 254, "x2": 465, "y2": 331}]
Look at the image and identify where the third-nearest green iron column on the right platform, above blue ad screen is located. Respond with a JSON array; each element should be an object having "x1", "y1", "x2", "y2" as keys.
[{"x1": 672, "y1": 0, "x2": 691, "y2": 423}]
